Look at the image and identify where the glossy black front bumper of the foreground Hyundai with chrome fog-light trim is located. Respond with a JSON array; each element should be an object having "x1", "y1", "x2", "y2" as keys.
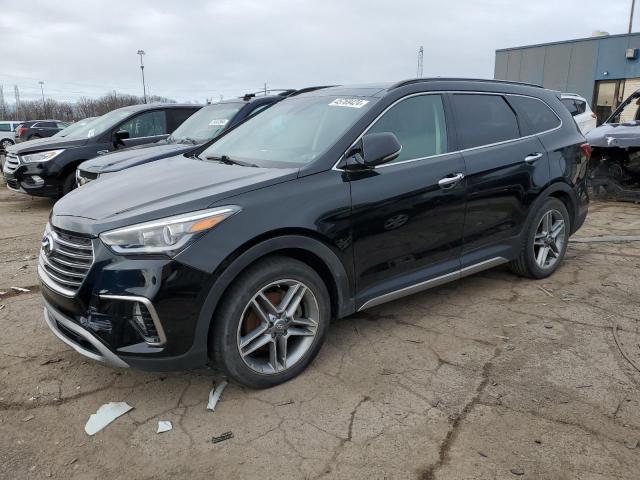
[{"x1": 38, "y1": 234, "x2": 213, "y2": 371}]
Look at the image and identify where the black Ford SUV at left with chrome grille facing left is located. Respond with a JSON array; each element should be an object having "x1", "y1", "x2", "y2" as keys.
[{"x1": 4, "y1": 104, "x2": 202, "y2": 197}]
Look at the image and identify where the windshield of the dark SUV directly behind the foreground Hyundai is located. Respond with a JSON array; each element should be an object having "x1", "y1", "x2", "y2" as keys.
[{"x1": 167, "y1": 102, "x2": 244, "y2": 144}]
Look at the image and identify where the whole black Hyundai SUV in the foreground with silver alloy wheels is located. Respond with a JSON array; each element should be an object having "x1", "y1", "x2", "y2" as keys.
[{"x1": 38, "y1": 79, "x2": 590, "y2": 387}]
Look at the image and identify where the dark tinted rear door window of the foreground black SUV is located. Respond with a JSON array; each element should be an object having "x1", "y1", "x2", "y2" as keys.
[{"x1": 452, "y1": 94, "x2": 520, "y2": 149}]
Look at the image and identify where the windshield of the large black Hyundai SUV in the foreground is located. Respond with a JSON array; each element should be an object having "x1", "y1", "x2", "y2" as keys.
[{"x1": 199, "y1": 97, "x2": 377, "y2": 167}]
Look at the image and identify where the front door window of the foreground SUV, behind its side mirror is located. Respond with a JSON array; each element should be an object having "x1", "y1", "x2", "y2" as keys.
[{"x1": 367, "y1": 95, "x2": 448, "y2": 163}]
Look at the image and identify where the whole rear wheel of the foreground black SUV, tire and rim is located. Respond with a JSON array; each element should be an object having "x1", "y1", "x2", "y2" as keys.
[{"x1": 510, "y1": 197, "x2": 571, "y2": 279}]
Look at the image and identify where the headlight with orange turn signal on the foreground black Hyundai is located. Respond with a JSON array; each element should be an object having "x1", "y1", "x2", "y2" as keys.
[{"x1": 100, "y1": 205, "x2": 241, "y2": 256}]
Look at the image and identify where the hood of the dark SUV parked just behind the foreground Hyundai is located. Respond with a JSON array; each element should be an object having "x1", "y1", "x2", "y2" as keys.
[{"x1": 79, "y1": 143, "x2": 194, "y2": 173}]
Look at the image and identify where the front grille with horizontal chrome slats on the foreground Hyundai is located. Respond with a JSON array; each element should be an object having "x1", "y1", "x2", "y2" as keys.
[{"x1": 40, "y1": 229, "x2": 93, "y2": 294}]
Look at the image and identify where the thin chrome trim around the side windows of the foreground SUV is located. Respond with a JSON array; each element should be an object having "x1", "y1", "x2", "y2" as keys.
[{"x1": 331, "y1": 90, "x2": 564, "y2": 172}]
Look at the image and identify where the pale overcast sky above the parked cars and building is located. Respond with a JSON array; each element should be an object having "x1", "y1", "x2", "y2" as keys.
[{"x1": 0, "y1": 0, "x2": 640, "y2": 103}]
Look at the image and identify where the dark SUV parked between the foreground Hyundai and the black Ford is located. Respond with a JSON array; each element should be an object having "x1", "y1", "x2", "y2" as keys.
[{"x1": 77, "y1": 90, "x2": 294, "y2": 186}]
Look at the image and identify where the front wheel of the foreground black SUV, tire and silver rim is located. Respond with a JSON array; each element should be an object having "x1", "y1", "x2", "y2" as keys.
[{"x1": 209, "y1": 256, "x2": 331, "y2": 388}]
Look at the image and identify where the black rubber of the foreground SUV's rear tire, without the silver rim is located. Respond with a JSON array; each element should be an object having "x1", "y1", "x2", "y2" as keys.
[{"x1": 510, "y1": 197, "x2": 571, "y2": 279}]
